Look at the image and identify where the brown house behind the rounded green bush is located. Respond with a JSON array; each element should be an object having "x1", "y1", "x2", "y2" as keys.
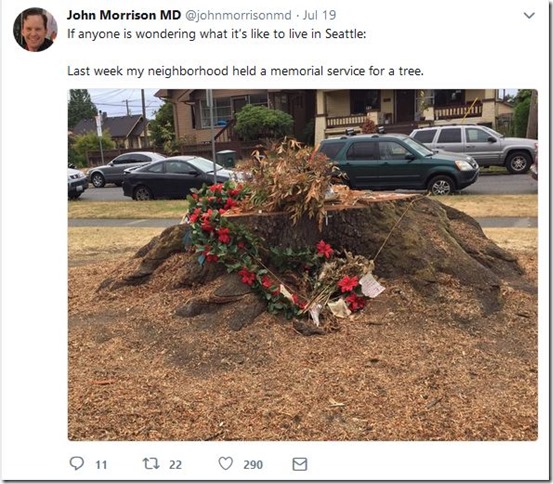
[{"x1": 155, "y1": 89, "x2": 315, "y2": 144}]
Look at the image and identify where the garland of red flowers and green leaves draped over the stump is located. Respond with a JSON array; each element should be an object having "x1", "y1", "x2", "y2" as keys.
[{"x1": 184, "y1": 180, "x2": 380, "y2": 324}]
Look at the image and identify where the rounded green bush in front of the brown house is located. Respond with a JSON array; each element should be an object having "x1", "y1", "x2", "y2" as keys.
[{"x1": 234, "y1": 104, "x2": 294, "y2": 141}]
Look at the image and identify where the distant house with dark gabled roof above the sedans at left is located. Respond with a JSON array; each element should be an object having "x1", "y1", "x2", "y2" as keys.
[{"x1": 73, "y1": 112, "x2": 148, "y2": 149}]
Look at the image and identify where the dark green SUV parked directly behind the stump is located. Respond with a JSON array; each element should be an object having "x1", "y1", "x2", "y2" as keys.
[{"x1": 317, "y1": 134, "x2": 479, "y2": 195}]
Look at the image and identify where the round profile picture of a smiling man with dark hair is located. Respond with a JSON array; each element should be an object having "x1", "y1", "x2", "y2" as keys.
[{"x1": 13, "y1": 7, "x2": 58, "y2": 52}]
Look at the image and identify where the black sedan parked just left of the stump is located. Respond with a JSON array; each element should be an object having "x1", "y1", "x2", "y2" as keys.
[{"x1": 123, "y1": 156, "x2": 234, "y2": 200}]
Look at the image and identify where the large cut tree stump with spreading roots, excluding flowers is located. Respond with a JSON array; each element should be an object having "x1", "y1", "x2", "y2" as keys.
[{"x1": 99, "y1": 194, "x2": 534, "y2": 326}]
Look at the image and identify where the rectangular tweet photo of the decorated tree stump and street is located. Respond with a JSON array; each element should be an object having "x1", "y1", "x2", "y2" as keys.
[{"x1": 68, "y1": 88, "x2": 539, "y2": 441}]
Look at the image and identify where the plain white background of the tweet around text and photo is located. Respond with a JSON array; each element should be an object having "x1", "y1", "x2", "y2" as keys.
[{"x1": 1, "y1": 0, "x2": 550, "y2": 480}]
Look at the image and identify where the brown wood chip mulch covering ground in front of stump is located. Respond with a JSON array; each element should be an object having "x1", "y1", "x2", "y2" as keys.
[{"x1": 68, "y1": 253, "x2": 538, "y2": 441}]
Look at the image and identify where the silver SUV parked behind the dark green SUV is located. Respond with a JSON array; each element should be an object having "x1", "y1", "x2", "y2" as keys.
[{"x1": 411, "y1": 124, "x2": 538, "y2": 174}]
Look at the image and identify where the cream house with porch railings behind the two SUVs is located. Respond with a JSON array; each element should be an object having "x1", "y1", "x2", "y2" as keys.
[{"x1": 315, "y1": 89, "x2": 513, "y2": 143}]
